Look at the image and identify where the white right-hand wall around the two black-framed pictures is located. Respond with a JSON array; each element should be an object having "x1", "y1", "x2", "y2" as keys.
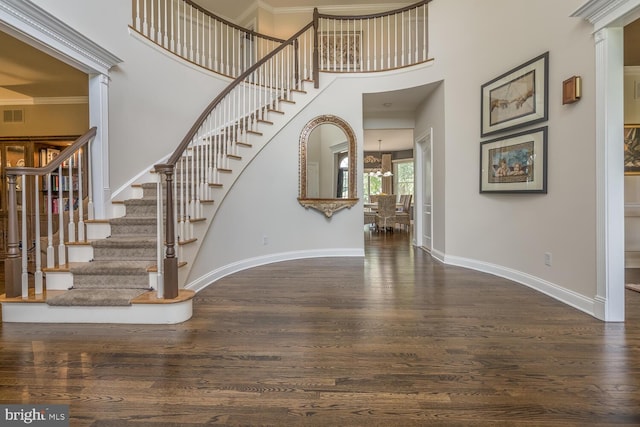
[{"x1": 430, "y1": 0, "x2": 596, "y2": 298}]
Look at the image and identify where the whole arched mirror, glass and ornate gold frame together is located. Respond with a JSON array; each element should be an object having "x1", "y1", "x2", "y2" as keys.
[{"x1": 298, "y1": 115, "x2": 358, "y2": 217}]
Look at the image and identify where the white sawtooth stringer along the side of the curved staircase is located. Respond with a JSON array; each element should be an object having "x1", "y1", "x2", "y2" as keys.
[{"x1": 172, "y1": 75, "x2": 337, "y2": 289}]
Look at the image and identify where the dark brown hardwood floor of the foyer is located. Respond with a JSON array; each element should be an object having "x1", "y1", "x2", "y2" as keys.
[{"x1": 0, "y1": 232, "x2": 640, "y2": 427}]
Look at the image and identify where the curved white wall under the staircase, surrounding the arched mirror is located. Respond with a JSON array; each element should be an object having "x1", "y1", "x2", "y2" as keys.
[{"x1": 188, "y1": 65, "x2": 436, "y2": 283}]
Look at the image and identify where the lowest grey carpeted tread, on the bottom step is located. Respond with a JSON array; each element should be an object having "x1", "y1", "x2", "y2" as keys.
[{"x1": 47, "y1": 289, "x2": 149, "y2": 307}]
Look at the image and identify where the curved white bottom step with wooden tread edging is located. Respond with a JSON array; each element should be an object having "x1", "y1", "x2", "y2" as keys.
[{"x1": 0, "y1": 289, "x2": 195, "y2": 324}]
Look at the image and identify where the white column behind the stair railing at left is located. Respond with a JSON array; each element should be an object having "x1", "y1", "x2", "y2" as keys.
[{"x1": 89, "y1": 74, "x2": 111, "y2": 219}]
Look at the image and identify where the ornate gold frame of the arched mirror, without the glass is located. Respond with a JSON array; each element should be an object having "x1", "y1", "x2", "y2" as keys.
[{"x1": 298, "y1": 114, "x2": 358, "y2": 218}]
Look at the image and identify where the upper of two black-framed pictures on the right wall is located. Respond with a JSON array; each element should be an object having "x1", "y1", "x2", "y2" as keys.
[{"x1": 480, "y1": 52, "x2": 549, "y2": 137}]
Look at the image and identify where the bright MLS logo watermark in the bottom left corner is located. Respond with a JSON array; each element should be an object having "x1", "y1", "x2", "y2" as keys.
[{"x1": 0, "y1": 405, "x2": 69, "y2": 427}]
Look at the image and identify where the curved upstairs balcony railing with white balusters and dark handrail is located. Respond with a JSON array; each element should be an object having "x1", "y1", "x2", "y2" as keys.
[{"x1": 132, "y1": 0, "x2": 430, "y2": 82}]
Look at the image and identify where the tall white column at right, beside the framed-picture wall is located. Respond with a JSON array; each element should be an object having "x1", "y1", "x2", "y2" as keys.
[{"x1": 594, "y1": 27, "x2": 624, "y2": 322}]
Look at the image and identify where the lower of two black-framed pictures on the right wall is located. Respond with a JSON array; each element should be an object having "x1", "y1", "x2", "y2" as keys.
[{"x1": 480, "y1": 126, "x2": 547, "y2": 193}]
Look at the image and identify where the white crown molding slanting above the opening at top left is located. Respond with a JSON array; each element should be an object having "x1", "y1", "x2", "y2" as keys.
[{"x1": 0, "y1": 0, "x2": 122, "y2": 74}]
